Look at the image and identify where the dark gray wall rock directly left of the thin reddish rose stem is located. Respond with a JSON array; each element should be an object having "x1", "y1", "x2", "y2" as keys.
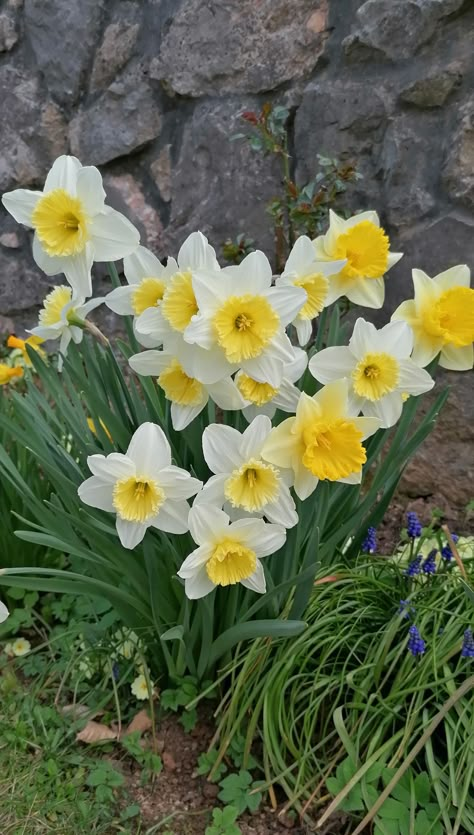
[{"x1": 165, "y1": 98, "x2": 281, "y2": 257}]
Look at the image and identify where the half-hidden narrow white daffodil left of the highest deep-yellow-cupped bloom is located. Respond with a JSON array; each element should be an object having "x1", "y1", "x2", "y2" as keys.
[{"x1": 275, "y1": 235, "x2": 347, "y2": 345}]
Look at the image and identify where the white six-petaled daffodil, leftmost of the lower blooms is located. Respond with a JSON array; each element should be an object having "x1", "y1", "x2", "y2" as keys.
[{"x1": 78, "y1": 423, "x2": 202, "y2": 548}]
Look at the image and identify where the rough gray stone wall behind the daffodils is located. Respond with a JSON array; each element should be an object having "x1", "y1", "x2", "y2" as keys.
[{"x1": 0, "y1": 0, "x2": 474, "y2": 510}]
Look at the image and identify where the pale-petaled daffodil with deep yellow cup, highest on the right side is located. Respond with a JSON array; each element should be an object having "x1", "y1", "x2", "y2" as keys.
[{"x1": 313, "y1": 209, "x2": 402, "y2": 307}]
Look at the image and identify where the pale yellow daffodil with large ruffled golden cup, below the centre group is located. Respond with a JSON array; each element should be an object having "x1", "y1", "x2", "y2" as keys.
[{"x1": 262, "y1": 379, "x2": 380, "y2": 499}]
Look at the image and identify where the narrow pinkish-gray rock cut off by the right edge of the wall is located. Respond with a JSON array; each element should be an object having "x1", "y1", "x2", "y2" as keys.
[{"x1": 443, "y1": 96, "x2": 474, "y2": 209}]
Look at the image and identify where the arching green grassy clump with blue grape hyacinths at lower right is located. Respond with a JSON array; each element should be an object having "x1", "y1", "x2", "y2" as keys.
[{"x1": 210, "y1": 543, "x2": 474, "y2": 835}]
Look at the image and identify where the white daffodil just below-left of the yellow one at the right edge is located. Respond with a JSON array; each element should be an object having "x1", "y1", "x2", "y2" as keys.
[{"x1": 309, "y1": 319, "x2": 434, "y2": 429}]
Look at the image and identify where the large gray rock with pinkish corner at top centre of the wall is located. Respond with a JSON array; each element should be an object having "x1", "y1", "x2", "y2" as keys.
[{"x1": 152, "y1": 0, "x2": 328, "y2": 96}]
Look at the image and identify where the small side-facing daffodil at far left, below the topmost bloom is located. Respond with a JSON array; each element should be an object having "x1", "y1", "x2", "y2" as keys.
[{"x1": 30, "y1": 285, "x2": 104, "y2": 371}]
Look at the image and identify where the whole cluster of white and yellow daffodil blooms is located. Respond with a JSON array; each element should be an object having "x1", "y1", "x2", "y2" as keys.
[{"x1": 3, "y1": 156, "x2": 474, "y2": 600}]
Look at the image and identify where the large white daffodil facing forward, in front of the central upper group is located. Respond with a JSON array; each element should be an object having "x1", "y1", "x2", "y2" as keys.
[{"x1": 184, "y1": 251, "x2": 307, "y2": 386}]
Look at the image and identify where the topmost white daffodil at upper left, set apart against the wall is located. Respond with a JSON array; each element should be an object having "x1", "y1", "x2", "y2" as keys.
[{"x1": 2, "y1": 156, "x2": 140, "y2": 297}]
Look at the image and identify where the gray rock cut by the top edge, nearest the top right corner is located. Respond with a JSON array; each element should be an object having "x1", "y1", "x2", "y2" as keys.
[{"x1": 343, "y1": 0, "x2": 464, "y2": 61}]
